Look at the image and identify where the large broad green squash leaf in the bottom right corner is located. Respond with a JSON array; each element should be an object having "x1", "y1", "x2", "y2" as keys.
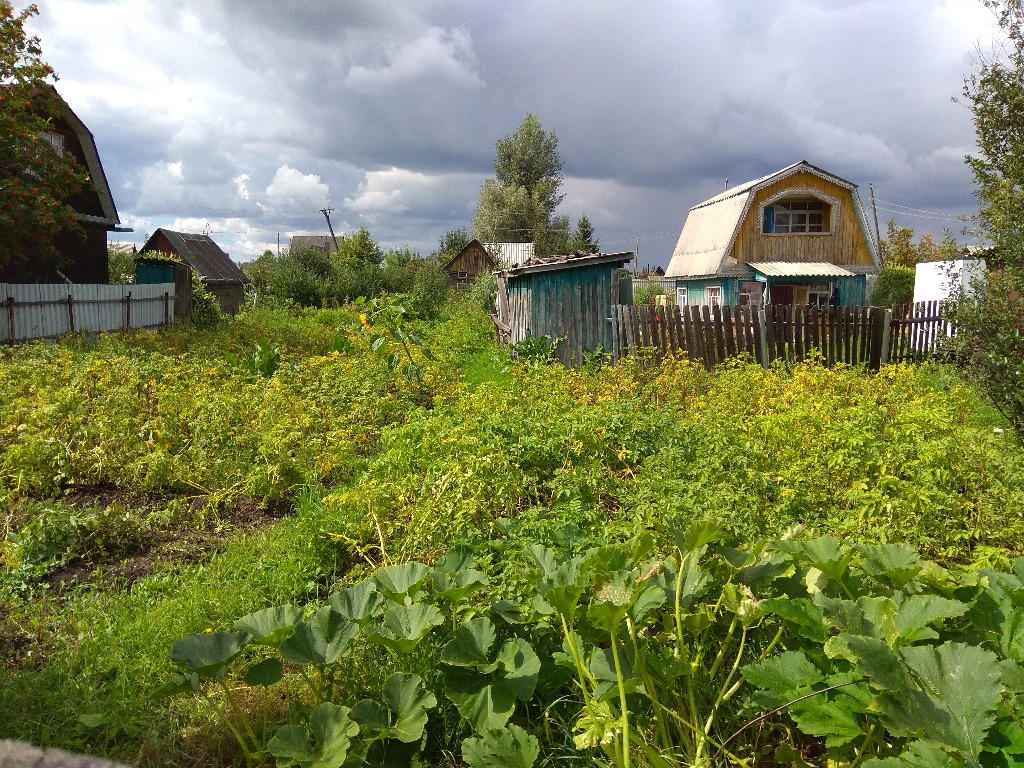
[{"x1": 879, "y1": 642, "x2": 1002, "y2": 765}]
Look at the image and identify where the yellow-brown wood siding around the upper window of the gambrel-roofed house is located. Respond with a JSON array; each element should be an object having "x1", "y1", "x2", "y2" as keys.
[{"x1": 732, "y1": 172, "x2": 873, "y2": 266}]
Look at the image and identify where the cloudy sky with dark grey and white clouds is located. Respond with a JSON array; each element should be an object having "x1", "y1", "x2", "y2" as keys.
[{"x1": 24, "y1": 0, "x2": 996, "y2": 265}]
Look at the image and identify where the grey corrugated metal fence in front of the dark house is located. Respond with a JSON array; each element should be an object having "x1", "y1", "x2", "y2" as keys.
[{"x1": 0, "y1": 283, "x2": 175, "y2": 343}]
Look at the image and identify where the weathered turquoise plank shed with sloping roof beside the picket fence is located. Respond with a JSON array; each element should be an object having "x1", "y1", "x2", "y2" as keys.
[{"x1": 495, "y1": 251, "x2": 633, "y2": 366}]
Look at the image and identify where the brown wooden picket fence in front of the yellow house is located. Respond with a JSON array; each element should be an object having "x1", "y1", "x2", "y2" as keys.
[{"x1": 609, "y1": 302, "x2": 951, "y2": 370}]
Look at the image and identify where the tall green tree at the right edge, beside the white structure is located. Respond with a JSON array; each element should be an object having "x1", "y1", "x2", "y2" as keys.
[{"x1": 952, "y1": 0, "x2": 1024, "y2": 437}]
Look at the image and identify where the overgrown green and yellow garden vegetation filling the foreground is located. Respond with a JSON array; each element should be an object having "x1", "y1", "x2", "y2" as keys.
[{"x1": 0, "y1": 290, "x2": 1024, "y2": 765}]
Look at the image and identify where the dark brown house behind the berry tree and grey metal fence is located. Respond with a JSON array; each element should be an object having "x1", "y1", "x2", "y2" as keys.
[{"x1": 0, "y1": 91, "x2": 121, "y2": 284}]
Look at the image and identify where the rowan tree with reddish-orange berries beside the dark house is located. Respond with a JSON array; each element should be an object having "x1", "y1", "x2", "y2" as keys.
[{"x1": 0, "y1": 0, "x2": 88, "y2": 269}]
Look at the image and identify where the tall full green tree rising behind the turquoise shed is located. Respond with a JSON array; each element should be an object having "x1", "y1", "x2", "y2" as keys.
[{"x1": 473, "y1": 114, "x2": 569, "y2": 256}]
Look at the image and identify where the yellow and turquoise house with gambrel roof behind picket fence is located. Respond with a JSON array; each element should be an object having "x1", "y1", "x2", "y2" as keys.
[{"x1": 666, "y1": 161, "x2": 881, "y2": 306}]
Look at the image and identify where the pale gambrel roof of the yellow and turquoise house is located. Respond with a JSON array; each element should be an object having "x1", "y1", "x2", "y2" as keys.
[{"x1": 666, "y1": 160, "x2": 879, "y2": 278}]
